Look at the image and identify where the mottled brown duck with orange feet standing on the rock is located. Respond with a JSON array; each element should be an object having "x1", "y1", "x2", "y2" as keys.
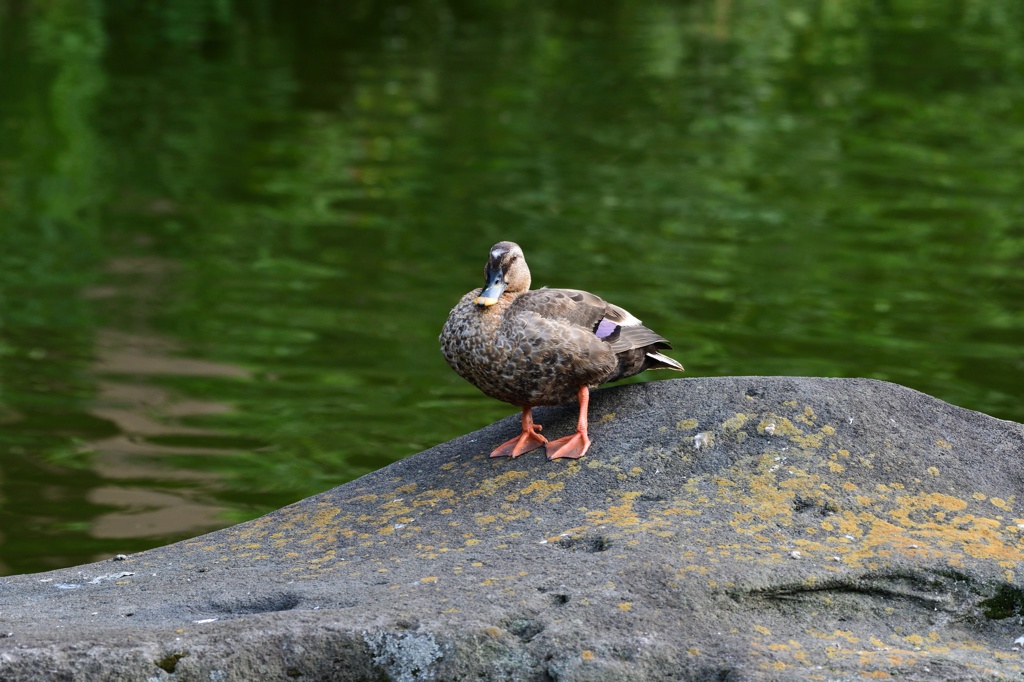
[{"x1": 438, "y1": 242, "x2": 683, "y2": 460}]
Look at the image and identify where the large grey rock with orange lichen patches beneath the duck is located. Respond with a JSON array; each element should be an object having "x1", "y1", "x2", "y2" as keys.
[{"x1": 0, "y1": 377, "x2": 1024, "y2": 682}]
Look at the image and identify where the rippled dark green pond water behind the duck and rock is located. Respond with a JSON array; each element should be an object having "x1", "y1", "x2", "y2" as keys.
[{"x1": 0, "y1": 0, "x2": 1024, "y2": 573}]
